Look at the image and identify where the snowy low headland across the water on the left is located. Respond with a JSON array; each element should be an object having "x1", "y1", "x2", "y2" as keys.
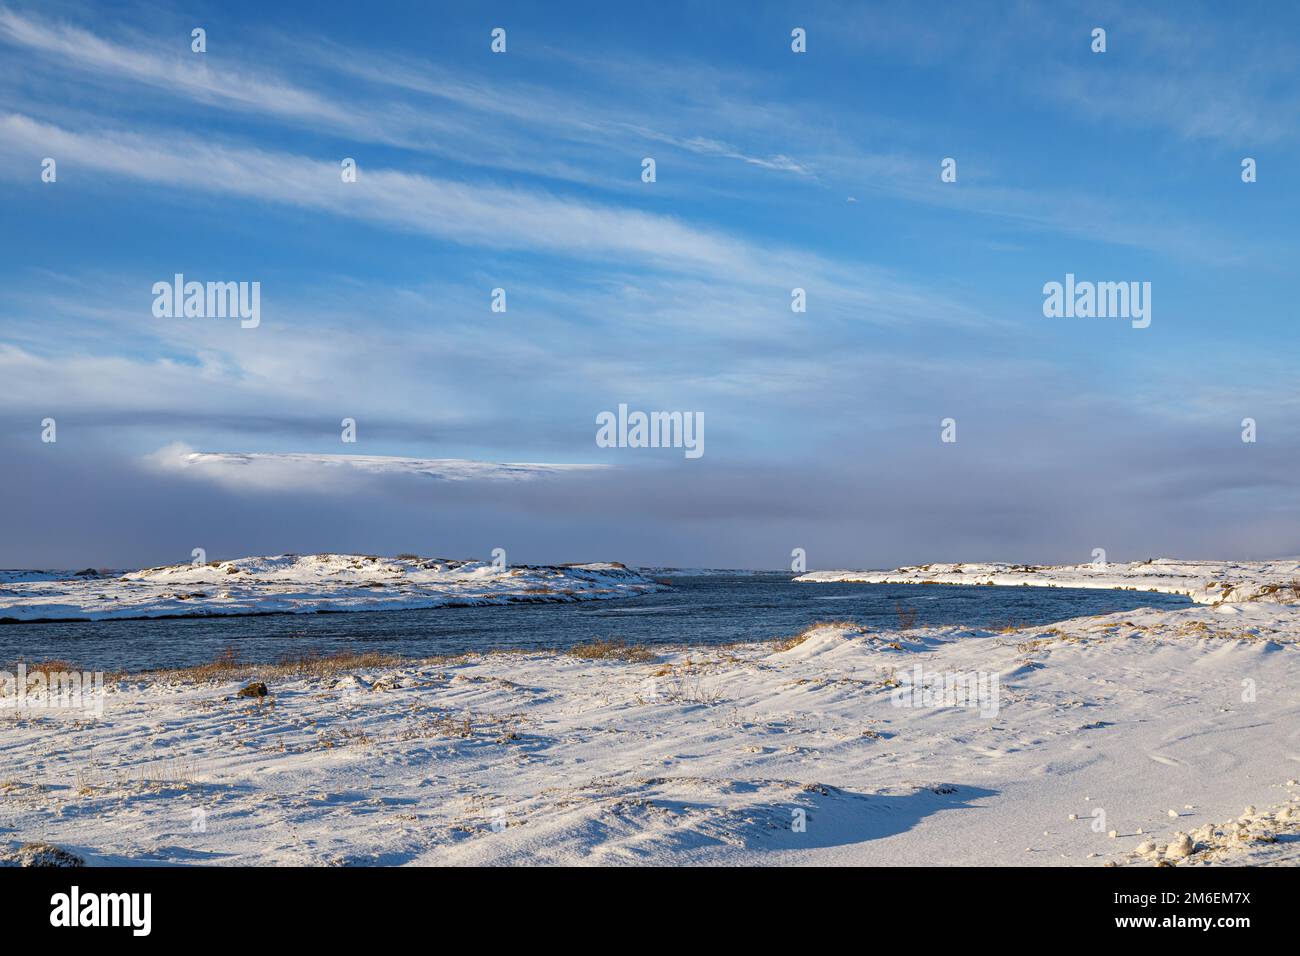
[{"x1": 0, "y1": 554, "x2": 660, "y2": 620}]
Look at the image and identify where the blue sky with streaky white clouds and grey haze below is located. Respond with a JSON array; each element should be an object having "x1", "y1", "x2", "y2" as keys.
[{"x1": 0, "y1": 0, "x2": 1300, "y2": 568}]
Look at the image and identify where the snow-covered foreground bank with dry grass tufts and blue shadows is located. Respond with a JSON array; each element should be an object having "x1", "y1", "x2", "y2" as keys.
[{"x1": 0, "y1": 564, "x2": 1300, "y2": 865}]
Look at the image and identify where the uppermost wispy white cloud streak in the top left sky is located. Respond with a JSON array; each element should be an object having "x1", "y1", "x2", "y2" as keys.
[{"x1": 0, "y1": 8, "x2": 809, "y2": 186}]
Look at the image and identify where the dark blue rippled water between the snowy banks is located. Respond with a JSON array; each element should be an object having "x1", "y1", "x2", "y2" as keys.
[{"x1": 0, "y1": 575, "x2": 1191, "y2": 671}]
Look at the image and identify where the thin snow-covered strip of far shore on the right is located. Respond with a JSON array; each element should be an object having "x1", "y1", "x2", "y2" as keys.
[{"x1": 794, "y1": 558, "x2": 1300, "y2": 604}]
